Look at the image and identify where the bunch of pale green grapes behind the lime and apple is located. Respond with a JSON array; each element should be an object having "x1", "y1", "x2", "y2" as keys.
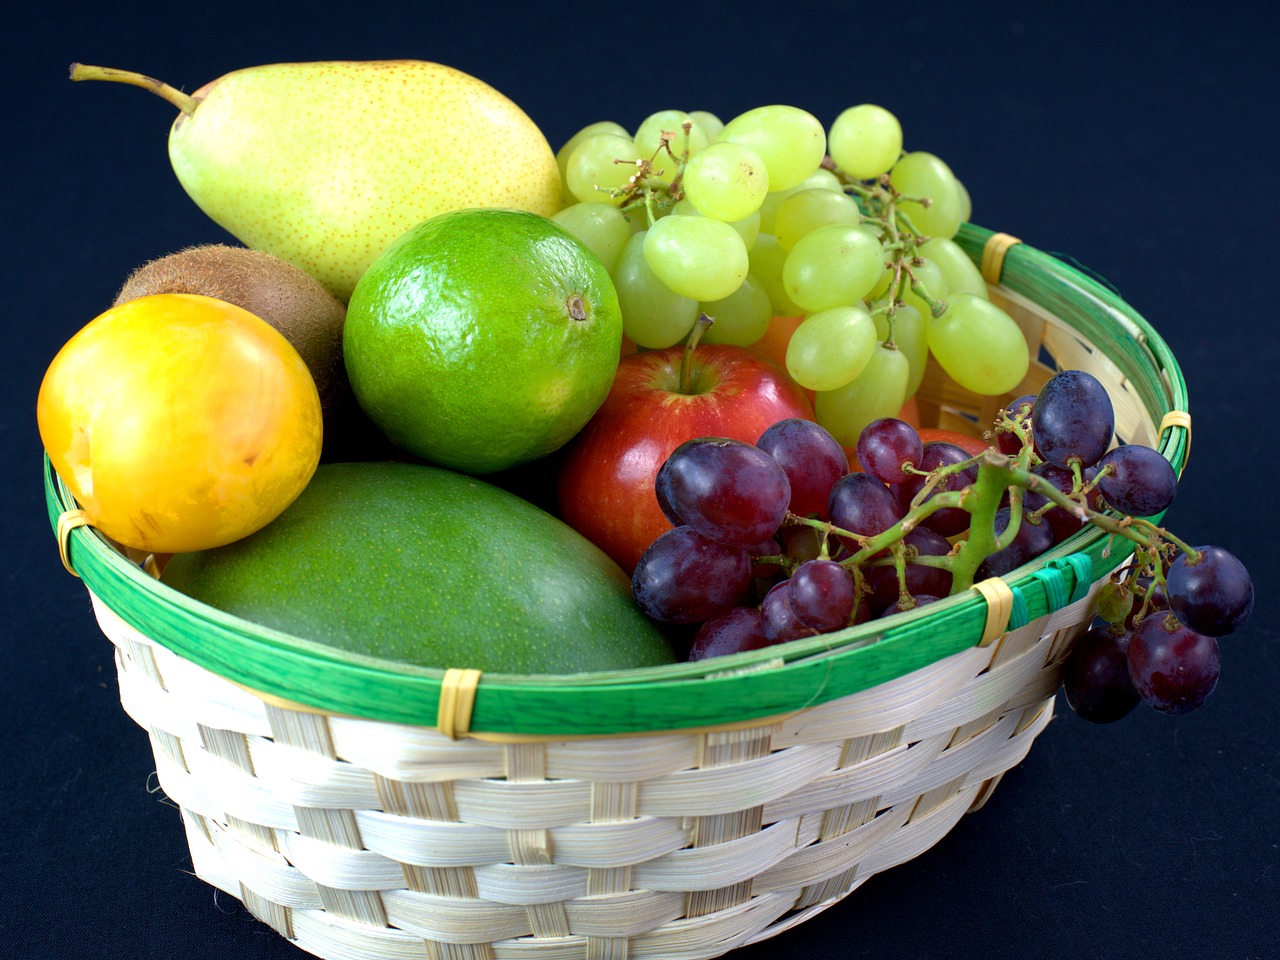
[{"x1": 554, "y1": 104, "x2": 1029, "y2": 445}]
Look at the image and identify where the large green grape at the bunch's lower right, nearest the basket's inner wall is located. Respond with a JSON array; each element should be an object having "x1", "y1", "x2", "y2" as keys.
[{"x1": 929, "y1": 293, "x2": 1030, "y2": 396}]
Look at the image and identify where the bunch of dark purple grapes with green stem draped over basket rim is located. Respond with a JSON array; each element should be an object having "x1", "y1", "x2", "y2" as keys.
[{"x1": 632, "y1": 370, "x2": 1253, "y2": 721}]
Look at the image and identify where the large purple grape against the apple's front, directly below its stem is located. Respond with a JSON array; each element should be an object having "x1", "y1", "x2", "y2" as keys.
[{"x1": 654, "y1": 436, "x2": 791, "y2": 547}]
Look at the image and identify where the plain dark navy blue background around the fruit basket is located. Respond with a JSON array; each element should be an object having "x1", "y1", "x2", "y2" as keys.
[{"x1": 0, "y1": 7, "x2": 1280, "y2": 960}]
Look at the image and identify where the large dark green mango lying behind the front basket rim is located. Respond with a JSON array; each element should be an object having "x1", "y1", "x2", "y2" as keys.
[{"x1": 164, "y1": 462, "x2": 677, "y2": 673}]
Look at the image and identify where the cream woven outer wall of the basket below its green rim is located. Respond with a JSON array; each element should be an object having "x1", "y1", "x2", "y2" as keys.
[{"x1": 95, "y1": 570, "x2": 1097, "y2": 960}]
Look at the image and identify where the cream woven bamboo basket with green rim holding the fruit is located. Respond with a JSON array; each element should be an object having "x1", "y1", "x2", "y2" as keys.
[{"x1": 46, "y1": 225, "x2": 1190, "y2": 960}]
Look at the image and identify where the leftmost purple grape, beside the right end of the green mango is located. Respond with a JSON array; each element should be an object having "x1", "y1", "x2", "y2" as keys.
[{"x1": 631, "y1": 526, "x2": 751, "y2": 623}]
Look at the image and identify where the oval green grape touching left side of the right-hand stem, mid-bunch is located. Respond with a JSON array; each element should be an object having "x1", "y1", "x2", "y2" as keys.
[{"x1": 782, "y1": 224, "x2": 884, "y2": 314}]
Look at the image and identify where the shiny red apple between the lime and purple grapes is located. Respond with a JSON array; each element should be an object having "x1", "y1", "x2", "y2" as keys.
[{"x1": 557, "y1": 344, "x2": 813, "y2": 573}]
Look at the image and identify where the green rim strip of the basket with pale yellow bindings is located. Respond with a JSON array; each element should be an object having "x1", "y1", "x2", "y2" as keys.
[{"x1": 44, "y1": 224, "x2": 1190, "y2": 740}]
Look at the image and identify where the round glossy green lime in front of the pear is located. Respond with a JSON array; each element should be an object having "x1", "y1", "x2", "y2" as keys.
[{"x1": 343, "y1": 209, "x2": 622, "y2": 474}]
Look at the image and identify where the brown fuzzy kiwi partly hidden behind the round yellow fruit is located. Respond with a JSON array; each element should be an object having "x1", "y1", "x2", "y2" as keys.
[{"x1": 113, "y1": 243, "x2": 389, "y2": 460}]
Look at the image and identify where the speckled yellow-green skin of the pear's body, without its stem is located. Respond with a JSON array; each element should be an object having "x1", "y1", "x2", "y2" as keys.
[{"x1": 169, "y1": 60, "x2": 561, "y2": 301}]
